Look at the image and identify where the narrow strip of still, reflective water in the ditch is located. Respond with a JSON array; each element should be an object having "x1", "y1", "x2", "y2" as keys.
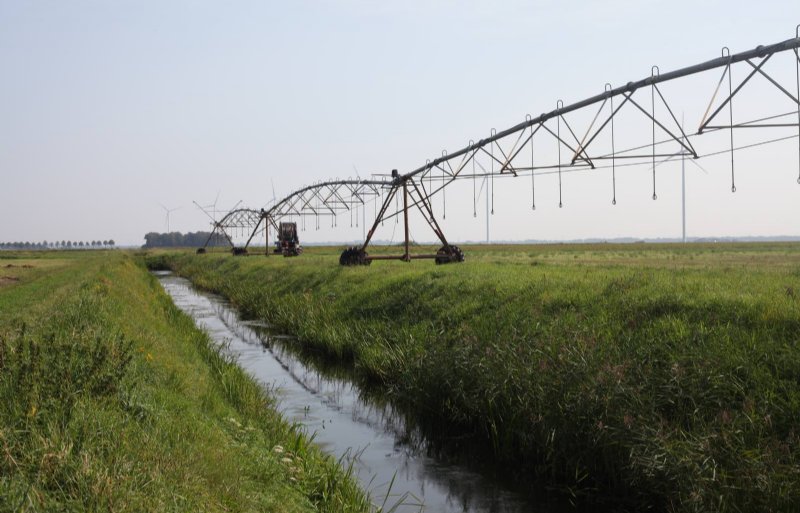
[{"x1": 156, "y1": 272, "x2": 565, "y2": 513}]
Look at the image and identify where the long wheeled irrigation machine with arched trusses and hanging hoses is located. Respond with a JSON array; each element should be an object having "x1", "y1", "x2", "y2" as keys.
[{"x1": 198, "y1": 26, "x2": 800, "y2": 266}]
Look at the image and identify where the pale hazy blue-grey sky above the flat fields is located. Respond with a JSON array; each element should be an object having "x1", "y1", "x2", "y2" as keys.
[{"x1": 0, "y1": 0, "x2": 800, "y2": 244}]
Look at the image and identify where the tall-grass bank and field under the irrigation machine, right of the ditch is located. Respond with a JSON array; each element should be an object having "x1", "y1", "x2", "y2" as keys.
[{"x1": 153, "y1": 244, "x2": 800, "y2": 511}]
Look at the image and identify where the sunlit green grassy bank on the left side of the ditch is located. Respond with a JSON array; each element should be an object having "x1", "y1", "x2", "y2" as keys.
[{"x1": 0, "y1": 252, "x2": 368, "y2": 512}]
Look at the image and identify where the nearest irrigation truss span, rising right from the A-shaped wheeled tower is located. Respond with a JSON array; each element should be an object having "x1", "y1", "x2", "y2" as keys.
[{"x1": 403, "y1": 32, "x2": 800, "y2": 212}]
